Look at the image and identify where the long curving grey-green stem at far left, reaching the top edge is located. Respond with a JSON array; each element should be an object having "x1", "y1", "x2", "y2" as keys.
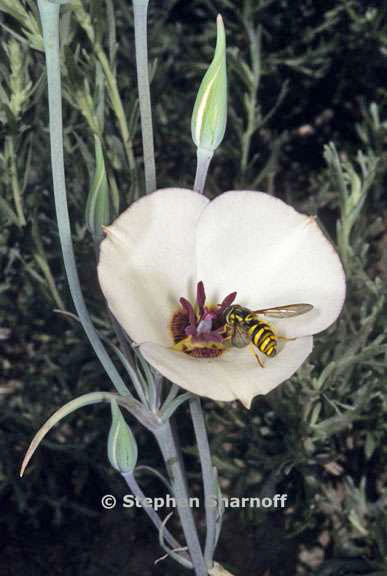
[{"x1": 38, "y1": 0, "x2": 130, "y2": 396}]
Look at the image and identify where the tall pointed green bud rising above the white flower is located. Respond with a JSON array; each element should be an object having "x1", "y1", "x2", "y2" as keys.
[{"x1": 191, "y1": 14, "x2": 227, "y2": 152}]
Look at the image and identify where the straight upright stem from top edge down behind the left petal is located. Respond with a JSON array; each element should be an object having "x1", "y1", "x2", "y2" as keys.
[{"x1": 133, "y1": 0, "x2": 156, "y2": 194}]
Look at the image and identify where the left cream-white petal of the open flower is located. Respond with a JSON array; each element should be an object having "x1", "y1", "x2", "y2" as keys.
[{"x1": 98, "y1": 188, "x2": 208, "y2": 345}]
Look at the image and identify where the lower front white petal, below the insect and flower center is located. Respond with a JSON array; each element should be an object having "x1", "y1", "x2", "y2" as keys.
[{"x1": 140, "y1": 336, "x2": 313, "y2": 408}]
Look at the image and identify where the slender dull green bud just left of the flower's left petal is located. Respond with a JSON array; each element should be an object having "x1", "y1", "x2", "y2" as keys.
[{"x1": 86, "y1": 136, "x2": 112, "y2": 244}]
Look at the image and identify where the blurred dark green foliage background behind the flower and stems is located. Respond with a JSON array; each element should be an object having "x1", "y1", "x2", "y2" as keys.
[{"x1": 0, "y1": 0, "x2": 387, "y2": 576}]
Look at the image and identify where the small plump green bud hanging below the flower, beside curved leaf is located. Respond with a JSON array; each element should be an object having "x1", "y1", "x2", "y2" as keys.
[{"x1": 108, "y1": 400, "x2": 138, "y2": 474}]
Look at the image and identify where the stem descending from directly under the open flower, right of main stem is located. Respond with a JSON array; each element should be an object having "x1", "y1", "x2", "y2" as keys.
[{"x1": 190, "y1": 396, "x2": 217, "y2": 568}]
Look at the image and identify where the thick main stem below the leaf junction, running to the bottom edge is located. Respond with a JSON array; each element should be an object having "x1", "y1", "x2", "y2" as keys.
[{"x1": 154, "y1": 421, "x2": 208, "y2": 576}]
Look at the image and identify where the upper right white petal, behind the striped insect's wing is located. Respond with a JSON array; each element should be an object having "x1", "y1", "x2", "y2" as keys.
[{"x1": 197, "y1": 191, "x2": 345, "y2": 336}]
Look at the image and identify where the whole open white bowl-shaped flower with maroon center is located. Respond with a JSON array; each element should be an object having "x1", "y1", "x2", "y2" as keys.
[{"x1": 98, "y1": 188, "x2": 345, "y2": 407}]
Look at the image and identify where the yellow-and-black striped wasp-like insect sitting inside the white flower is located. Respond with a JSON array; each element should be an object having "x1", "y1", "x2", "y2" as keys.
[{"x1": 223, "y1": 304, "x2": 313, "y2": 368}]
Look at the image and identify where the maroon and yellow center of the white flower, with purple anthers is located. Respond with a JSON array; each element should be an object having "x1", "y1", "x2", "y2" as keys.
[{"x1": 170, "y1": 282, "x2": 236, "y2": 358}]
